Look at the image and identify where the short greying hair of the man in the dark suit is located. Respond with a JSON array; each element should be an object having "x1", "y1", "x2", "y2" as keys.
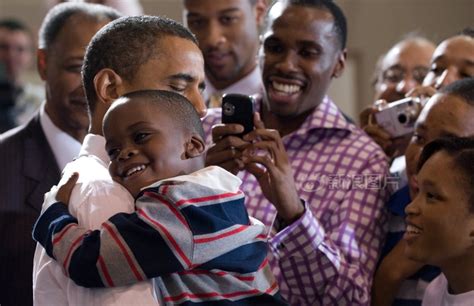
[{"x1": 38, "y1": 2, "x2": 121, "y2": 50}]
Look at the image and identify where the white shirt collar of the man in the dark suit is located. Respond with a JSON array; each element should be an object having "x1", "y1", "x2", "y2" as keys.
[{"x1": 40, "y1": 104, "x2": 81, "y2": 170}]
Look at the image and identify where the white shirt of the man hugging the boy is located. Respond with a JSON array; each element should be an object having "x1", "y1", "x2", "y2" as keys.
[{"x1": 33, "y1": 134, "x2": 157, "y2": 306}]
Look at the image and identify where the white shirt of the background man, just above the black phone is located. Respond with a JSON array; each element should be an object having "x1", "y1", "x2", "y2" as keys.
[{"x1": 203, "y1": 65, "x2": 263, "y2": 107}]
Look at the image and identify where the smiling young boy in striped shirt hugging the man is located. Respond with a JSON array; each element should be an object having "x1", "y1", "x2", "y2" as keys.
[{"x1": 33, "y1": 90, "x2": 285, "y2": 305}]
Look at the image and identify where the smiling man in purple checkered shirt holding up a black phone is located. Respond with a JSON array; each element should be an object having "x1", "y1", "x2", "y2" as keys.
[{"x1": 204, "y1": 0, "x2": 391, "y2": 305}]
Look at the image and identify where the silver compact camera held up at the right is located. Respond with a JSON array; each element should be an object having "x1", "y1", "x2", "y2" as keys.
[{"x1": 374, "y1": 97, "x2": 421, "y2": 138}]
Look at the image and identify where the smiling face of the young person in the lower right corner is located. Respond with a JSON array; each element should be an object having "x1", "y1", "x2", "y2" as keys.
[{"x1": 404, "y1": 151, "x2": 474, "y2": 267}]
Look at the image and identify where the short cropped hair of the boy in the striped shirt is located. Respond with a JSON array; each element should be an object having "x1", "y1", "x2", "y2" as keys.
[{"x1": 115, "y1": 89, "x2": 205, "y2": 139}]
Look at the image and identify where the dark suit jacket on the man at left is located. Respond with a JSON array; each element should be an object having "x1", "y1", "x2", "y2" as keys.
[{"x1": 0, "y1": 114, "x2": 60, "y2": 306}]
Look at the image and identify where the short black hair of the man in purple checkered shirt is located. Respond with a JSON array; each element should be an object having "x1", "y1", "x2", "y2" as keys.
[{"x1": 267, "y1": 0, "x2": 347, "y2": 50}]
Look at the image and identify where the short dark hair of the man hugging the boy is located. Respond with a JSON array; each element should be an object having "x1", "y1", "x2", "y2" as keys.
[{"x1": 82, "y1": 16, "x2": 198, "y2": 111}]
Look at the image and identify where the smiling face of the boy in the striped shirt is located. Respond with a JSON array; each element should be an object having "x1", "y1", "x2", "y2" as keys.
[{"x1": 104, "y1": 98, "x2": 188, "y2": 197}]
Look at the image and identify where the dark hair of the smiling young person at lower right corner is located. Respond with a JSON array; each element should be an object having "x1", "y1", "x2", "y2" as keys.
[{"x1": 417, "y1": 137, "x2": 474, "y2": 213}]
